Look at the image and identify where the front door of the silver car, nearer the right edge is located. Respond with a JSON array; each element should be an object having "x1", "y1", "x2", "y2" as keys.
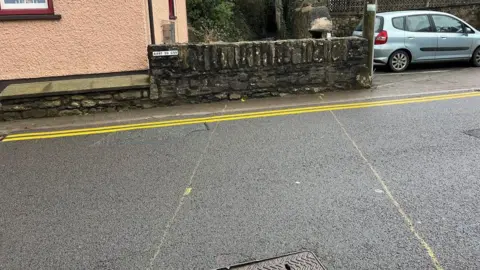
[{"x1": 432, "y1": 15, "x2": 473, "y2": 60}]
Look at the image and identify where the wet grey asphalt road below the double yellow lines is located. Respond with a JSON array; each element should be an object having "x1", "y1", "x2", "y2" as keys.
[{"x1": 0, "y1": 94, "x2": 480, "y2": 269}]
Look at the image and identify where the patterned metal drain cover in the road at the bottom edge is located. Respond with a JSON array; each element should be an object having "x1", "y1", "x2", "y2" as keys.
[{"x1": 218, "y1": 251, "x2": 326, "y2": 270}]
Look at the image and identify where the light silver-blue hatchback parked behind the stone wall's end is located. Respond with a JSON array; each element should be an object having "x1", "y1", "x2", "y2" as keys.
[{"x1": 353, "y1": 11, "x2": 480, "y2": 72}]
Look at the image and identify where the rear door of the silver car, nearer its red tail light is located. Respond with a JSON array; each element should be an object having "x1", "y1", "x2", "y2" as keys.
[{"x1": 405, "y1": 15, "x2": 438, "y2": 62}]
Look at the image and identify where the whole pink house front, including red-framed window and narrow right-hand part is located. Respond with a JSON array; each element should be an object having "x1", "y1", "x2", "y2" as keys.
[{"x1": 0, "y1": 0, "x2": 188, "y2": 81}]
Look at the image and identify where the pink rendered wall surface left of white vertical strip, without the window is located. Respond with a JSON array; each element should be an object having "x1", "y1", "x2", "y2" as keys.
[{"x1": 0, "y1": 0, "x2": 150, "y2": 80}]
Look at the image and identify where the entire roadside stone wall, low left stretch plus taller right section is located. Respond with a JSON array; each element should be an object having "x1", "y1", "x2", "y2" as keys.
[{"x1": 0, "y1": 37, "x2": 370, "y2": 120}]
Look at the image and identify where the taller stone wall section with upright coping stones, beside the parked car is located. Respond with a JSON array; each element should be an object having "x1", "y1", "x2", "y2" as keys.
[{"x1": 149, "y1": 37, "x2": 370, "y2": 102}]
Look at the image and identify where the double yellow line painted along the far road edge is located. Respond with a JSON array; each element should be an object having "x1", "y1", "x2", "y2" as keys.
[{"x1": 3, "y1": 92, "x2": 480, "y2": 142}]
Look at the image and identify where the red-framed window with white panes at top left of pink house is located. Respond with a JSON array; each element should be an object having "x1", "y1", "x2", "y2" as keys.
[{"x1": 0, "y1": 0, "x2": 53, "y2": 15}]
